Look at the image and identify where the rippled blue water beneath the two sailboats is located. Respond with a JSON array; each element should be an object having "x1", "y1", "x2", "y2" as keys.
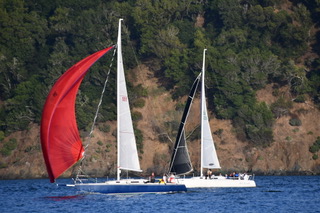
[{"x1": 0, "y1": 176, "x2": 320, "y2": 213}]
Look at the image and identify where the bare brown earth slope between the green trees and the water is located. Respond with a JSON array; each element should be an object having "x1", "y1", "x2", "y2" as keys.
[{"x1": 0, "y1": 65, "x2": 320, "y2": 179}]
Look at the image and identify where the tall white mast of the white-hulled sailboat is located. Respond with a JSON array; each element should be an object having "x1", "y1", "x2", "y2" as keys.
[{"x1": 200, "y1": 49, "x2": 207, "y2": 177}]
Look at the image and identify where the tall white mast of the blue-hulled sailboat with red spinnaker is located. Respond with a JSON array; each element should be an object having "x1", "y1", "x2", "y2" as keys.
[{"x1": 117, "y1": 19, "x2": 123, "y2": 180}]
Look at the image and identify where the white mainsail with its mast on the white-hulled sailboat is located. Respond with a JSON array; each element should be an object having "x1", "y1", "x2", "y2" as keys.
[{"x1": 200, "y1": 49, "x2": 221, "y2": 176}]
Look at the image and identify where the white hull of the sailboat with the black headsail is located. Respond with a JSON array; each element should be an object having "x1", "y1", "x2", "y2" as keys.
[{"x1": 178, "y1": 176, "x2": 256, "y2": 188}]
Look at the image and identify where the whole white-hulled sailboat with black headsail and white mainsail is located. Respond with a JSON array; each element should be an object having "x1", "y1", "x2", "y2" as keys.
[{"x1": 169, "y1": 49, "x2": 256, "y2": 188}]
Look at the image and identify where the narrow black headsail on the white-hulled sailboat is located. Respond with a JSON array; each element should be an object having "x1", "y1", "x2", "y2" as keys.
[{"x1": 169, "y1": 73, "x2": 201, "y2": 175}]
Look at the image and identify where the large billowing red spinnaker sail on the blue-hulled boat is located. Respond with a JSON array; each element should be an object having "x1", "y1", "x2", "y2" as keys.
[{"x1": 40, "y1": 46, "x2": 113, "y2": 183}]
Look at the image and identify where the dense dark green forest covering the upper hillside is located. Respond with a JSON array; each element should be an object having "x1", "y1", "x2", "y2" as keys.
[{"x1": 0, "y1": 0, "x2": 320, "y2": 154}]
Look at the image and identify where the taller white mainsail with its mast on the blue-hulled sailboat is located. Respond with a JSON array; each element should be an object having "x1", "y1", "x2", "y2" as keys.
[{"x1": 117, "y1": 19, "x2": 141, "y2": 180}]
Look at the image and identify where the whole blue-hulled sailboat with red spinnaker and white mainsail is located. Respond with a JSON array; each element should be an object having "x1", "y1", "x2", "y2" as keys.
[{"x1": 40, "y1": 19, "x2": 186, "y2": 194}]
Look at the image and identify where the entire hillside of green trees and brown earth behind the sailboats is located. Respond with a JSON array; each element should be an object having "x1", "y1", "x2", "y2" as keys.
[{"x1": 0, "y1": 0, "x2": 320, "y2": 181}]
